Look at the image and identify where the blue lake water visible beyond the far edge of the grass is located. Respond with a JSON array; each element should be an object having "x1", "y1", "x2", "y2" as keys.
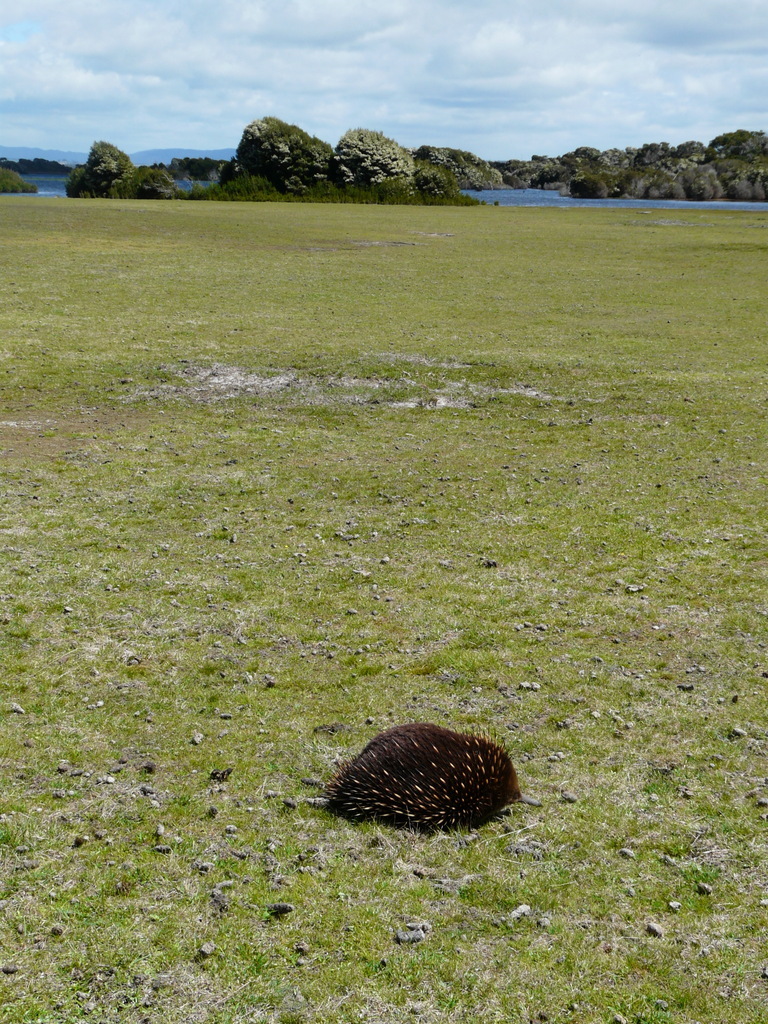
[{"x1": 4, "y1": 174, "x2": 768, "y2": 212}]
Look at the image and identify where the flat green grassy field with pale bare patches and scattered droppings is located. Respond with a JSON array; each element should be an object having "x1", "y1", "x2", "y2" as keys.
[{"x1": 0, "y1": 198, "x2": 768, "y2": 1024}]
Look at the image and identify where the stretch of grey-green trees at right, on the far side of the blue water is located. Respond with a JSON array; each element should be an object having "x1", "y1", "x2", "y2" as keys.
[{"x1": 494, "y1": 129, "x2": 768, "y2": 202}]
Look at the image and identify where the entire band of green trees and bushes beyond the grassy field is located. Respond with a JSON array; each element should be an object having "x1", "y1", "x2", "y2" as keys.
[{"x1": 58, "y1": 123, "x2": 768, "y2": 205}]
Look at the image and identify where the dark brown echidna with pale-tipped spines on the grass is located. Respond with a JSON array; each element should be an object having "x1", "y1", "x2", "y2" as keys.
[{"x1": 326, "y1": 722, "x2": 534, "y2": 831}]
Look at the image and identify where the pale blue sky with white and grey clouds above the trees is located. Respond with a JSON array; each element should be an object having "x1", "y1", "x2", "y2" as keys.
[{"x1": 0, "y1": 0, "x2": 768, "y2": 160}]
